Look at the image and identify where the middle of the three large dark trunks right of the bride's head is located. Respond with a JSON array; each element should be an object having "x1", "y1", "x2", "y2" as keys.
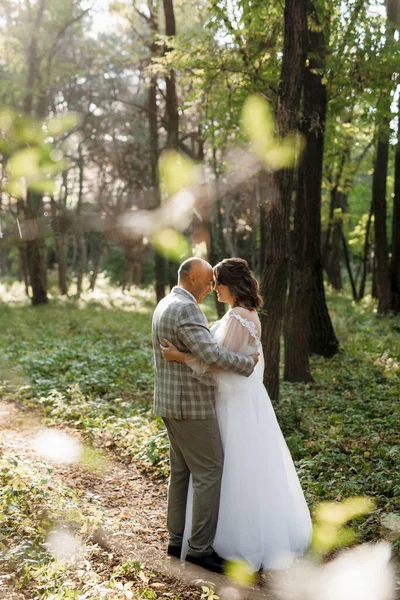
[{"x1": 284, "y1": 2, "x2": 327, "y2": 382}]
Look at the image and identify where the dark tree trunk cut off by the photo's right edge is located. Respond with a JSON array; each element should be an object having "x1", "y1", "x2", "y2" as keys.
[{"x1": 390, "y1": 99, "x2": 400, "y2": 313}]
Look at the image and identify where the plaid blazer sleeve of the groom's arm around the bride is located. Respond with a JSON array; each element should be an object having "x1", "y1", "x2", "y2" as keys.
[{"x1": 177, "y1": 302, "x2": 254, "y2": 377}]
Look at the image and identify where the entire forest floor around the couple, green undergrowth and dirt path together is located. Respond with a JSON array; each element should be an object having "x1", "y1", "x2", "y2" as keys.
[{"x1": 0, "y1": 280, "x2": 400, "y2": 600}]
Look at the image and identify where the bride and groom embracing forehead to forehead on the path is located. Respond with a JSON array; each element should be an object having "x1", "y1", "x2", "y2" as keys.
[{"x1": 153, "y1": 258, "x2": 311, "y2": 573}]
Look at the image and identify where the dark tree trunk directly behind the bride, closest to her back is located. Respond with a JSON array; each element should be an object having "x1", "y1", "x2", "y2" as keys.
[{"x1": 261, "y1": 0, "x2": 307, "y2": 400}]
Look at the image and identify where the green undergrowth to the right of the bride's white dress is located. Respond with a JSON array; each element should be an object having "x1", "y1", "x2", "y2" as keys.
[{"x1": 276, "y1": 294, "x2": 400, "y2": 551}]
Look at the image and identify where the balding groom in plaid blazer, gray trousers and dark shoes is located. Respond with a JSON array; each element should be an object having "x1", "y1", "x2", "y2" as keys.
[{"x1": 152, "y1": 258, "x2": 258, "y2": 573}]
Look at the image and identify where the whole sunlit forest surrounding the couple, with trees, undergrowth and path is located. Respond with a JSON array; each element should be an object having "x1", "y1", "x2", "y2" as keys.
[{"x1": 0, "y1": 0, "x2": 400, "y2": 600}]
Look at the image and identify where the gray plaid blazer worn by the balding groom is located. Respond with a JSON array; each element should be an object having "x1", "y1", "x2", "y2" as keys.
[{"x1": 152, "y1": 286, "x2": 254, "y2": 419}]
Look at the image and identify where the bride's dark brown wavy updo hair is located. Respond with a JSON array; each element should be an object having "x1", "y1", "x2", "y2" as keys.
[{"x1": 214, "y1": 258, "x2": 263, "y2": 310}]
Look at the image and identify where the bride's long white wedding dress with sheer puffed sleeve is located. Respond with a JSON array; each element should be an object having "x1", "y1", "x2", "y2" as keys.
[{"x1": 182, "y1": 307, "x2": 312, "y2": 571}]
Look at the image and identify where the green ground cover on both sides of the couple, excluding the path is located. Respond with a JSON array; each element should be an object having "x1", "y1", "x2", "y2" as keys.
[{"x1": 0, "y1": 280, "x2": 400, "y2": 592}]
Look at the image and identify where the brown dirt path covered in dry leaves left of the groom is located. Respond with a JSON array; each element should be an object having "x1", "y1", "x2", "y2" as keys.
[{"x1": 0, "y1": 401, "x2": 270, "y2": 600}]
